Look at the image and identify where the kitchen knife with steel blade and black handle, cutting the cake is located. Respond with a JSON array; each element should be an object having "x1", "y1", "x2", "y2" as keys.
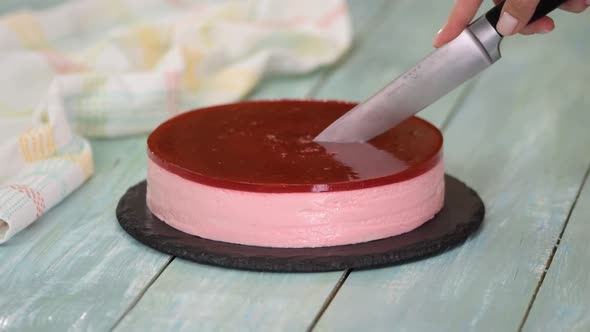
[{"x1": 314, "y1": 0, "x2": 566, "y2": 143}]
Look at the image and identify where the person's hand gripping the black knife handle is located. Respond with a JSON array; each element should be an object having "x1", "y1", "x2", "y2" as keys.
[{"x1": 434, "y1": 0, "x2": 590, "y2": 47}]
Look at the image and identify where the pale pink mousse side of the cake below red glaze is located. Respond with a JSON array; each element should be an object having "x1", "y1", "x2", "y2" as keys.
[{"x1": 147, "y1": 158, "x2": 444, "y2": 247}]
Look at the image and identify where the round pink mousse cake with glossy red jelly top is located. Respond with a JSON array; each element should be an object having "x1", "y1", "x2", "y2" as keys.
[{"x1": 146, "y1": 100, "x2": 444, "y2": 248}]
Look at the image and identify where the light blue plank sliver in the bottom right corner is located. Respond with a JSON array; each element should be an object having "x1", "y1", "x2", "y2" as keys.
[{"x1": 523, "y1": 175, "x2": 590, "y2": 332}]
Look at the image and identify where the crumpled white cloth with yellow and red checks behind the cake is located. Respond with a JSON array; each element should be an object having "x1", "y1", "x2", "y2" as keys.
[{"x1": 0, "y1": 0, "x2": 351, "y2": 243}]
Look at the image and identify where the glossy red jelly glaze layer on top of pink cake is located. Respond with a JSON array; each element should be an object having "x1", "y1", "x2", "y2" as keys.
[{"x1": 148, "y1": 100, "x2": 443, "y2": 193}]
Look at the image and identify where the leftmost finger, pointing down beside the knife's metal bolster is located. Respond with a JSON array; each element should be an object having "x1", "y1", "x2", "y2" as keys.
[{"x1": 434, "y1": 0, "x2": 482, "y2": 47}]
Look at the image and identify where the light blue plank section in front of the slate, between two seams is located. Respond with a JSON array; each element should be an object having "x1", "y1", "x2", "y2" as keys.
[{"x1": 117, "y1": 258, "x2": 346, "y2": 331}]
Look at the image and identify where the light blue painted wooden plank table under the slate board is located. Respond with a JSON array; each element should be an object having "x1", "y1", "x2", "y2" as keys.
[{"x1": 0, "y1": 0, "x2": 590, "y2": 331}]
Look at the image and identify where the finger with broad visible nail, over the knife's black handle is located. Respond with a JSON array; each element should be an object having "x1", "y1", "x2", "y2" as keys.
[{"x1": 496, "y1": 0, "x2": 539, "y2": 36}]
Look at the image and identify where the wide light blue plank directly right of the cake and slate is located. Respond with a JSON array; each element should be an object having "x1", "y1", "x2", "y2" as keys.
[{"x1": 317, "y1": 10, "x2": 590, "y2": 331}]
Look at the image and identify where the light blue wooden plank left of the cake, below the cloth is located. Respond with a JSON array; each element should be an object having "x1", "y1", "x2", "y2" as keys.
[{"x1": 0, "y1": 137, "x2": 175, "y2": 331}]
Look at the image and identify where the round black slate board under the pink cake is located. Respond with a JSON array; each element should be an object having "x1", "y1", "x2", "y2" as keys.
[{"x1": 117, "y1": 175, "x2": 485, "y2": 272}]
